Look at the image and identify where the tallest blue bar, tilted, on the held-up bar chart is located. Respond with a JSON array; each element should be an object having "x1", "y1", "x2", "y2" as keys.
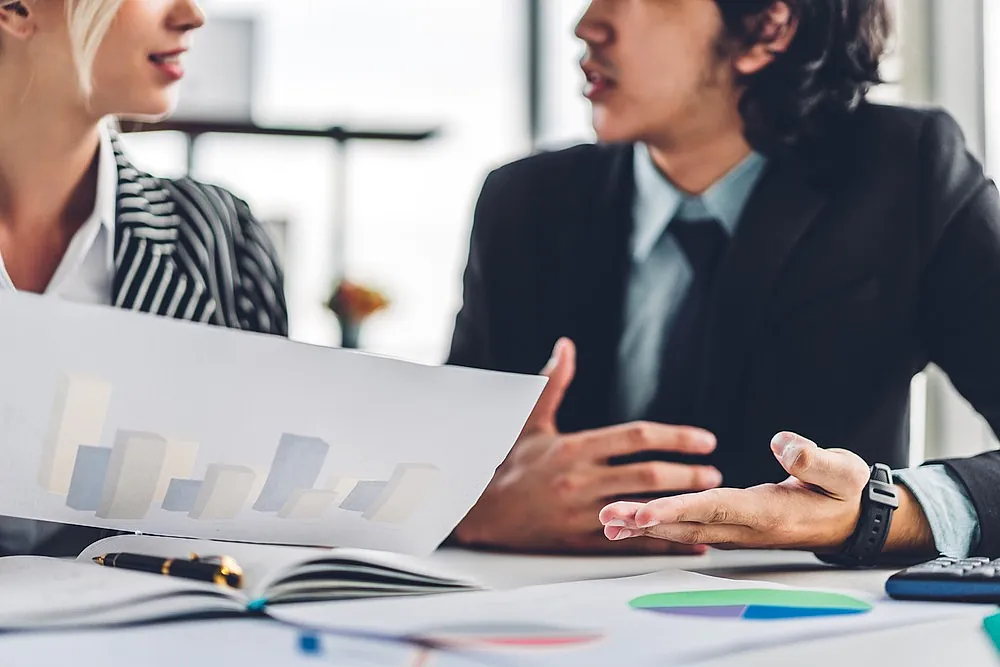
[{"x1": 253, "y1": 433, "x2": 330, "y2": 512}]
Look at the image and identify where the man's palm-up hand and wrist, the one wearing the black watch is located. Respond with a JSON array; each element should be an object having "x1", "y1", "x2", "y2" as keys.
[{"x1": 600, "y1": 433, "x2": 933, "y2": 553}]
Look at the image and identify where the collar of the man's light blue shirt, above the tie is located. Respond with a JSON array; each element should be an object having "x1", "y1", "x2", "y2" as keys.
[{"x1": 632, "y1": 143, "x2": 767, "y2": 262}]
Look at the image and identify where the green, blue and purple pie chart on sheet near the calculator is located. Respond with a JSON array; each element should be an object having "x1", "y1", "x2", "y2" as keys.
[{"x1": 629, "y1": 588, "x2": 872, "y2": 621}]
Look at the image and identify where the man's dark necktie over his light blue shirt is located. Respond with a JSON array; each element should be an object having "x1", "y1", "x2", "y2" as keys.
[{"x1": 649, "y1": 219, "x2": 729, "y2": 425}]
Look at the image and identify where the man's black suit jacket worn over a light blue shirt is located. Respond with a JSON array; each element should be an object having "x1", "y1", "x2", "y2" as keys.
[{"x1": 449, "y1": 104, "x2": 1000, "y2": 553}]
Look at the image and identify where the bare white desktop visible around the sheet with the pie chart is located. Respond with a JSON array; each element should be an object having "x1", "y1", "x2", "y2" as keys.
[{"x1": 432, "y1": 549, "x2": 1000, "y2": 667}]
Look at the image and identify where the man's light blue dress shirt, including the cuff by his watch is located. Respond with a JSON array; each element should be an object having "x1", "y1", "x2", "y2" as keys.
[{"x1": 616, "y1": 144, "x2": 979, "y2": 557}]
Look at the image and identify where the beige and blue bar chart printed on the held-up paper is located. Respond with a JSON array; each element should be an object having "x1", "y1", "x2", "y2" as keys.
[{"x1": 38, "y1": 374, "x2": 441, "y2": 526}]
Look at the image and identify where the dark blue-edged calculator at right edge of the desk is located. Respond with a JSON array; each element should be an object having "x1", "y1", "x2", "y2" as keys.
[{"x1": 885, "y1": 556, "x2": 1000, "y2": 604}]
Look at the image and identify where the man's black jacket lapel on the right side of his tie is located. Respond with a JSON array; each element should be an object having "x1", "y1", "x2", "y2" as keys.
[{"x1": 700, "y1": 159, "x2": 826, "y2": 431}]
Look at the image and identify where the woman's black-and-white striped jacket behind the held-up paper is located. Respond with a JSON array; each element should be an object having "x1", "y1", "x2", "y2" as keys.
[{"x1": 9, "y1": 136, "x2": 288, "y2": 556}]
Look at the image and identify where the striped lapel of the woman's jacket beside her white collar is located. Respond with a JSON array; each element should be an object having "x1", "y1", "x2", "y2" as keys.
[{"x1": 112, "y1": 137, "x2": 218, "y2": 322}]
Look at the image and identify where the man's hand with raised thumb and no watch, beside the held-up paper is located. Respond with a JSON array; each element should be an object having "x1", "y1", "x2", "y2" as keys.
[{"x1": 455, "y1": 339, "x2": 722, "y2": 553}]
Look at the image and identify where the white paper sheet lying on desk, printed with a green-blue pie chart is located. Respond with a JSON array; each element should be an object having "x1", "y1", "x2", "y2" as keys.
[{"x1": 271, "y1": 571, "x2": 994, "y2": 667}]
